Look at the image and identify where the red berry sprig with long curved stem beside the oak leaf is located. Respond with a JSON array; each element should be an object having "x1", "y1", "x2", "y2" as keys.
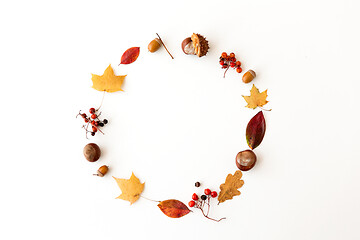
[{"x1": 188, "y1": 182, "x2": 225, "y2": 222}]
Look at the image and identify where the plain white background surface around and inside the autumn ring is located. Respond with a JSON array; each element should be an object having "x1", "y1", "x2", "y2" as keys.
[{"x1": 0, "y1": 0, "x2": 360, "y2": 240}]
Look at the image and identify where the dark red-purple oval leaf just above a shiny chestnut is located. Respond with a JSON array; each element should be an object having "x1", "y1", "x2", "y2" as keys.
[{"x1": 246, "y1": 111, "x2": 266, "y2": 149}]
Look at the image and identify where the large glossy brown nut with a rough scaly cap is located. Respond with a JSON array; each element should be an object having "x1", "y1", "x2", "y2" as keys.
[{"x1": 181, "y1": 33, "x2": 209, "y2": 57}]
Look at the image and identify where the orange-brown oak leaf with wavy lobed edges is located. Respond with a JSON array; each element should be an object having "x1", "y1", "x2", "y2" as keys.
[{"x1": 218, "y1": 170, "x2": 244, "y2": 203}]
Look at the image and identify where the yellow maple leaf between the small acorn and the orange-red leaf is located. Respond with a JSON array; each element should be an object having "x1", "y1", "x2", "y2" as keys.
[{"x1": 113, "y1": 173, "x2": 145, "y2": 205}]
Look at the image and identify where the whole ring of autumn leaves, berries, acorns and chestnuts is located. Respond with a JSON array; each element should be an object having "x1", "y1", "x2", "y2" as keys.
[{"x1": 77, "y1": 33, "x2": 271, "y2": 222}]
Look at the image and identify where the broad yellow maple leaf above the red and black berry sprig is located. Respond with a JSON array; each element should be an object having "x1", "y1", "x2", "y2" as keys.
[{"x1": 91, "y1": 65, "x2": 126, "y2": 92}]
